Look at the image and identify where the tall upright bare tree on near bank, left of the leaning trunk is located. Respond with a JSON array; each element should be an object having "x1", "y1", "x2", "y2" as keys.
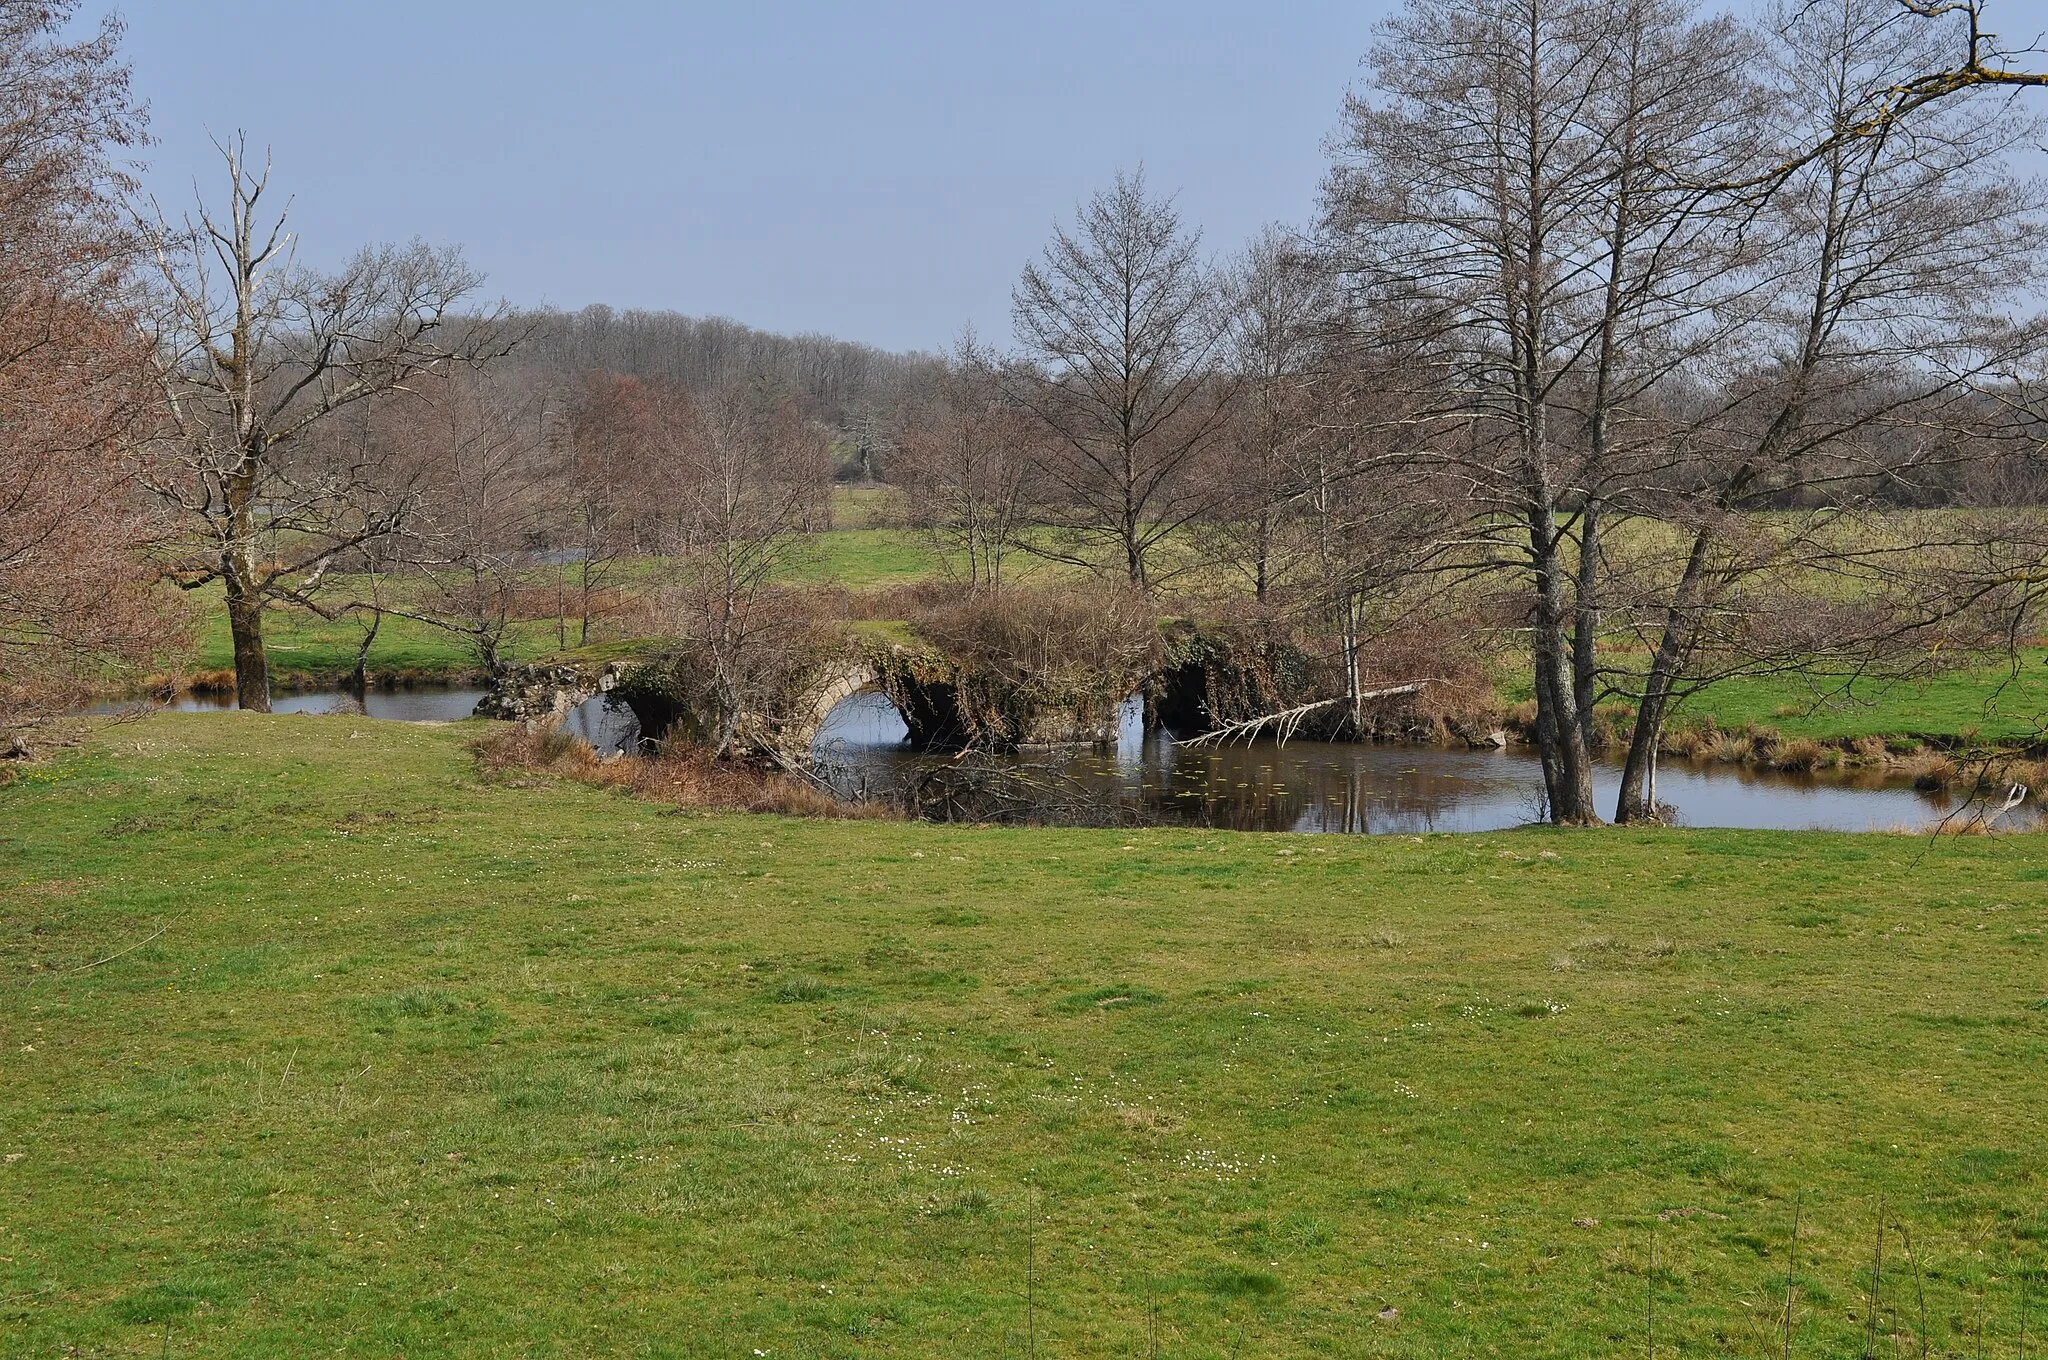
[{"x1": 1325, "y1": 0, "x2": 1646, "y2": 823}]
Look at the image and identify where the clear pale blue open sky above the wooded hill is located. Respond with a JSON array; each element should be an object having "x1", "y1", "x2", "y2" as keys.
[{"x1": 88, "y1": 0, "x2": 1386, "y2": 348}]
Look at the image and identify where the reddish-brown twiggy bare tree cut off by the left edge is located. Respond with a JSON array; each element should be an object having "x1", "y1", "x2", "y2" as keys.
[{"x1": 0, "y1": 2, "x2": 176, "y2": 756}]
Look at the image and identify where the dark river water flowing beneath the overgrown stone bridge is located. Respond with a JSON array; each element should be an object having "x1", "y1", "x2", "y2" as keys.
[{"x1": 98, "y1": 688, "x2": 2040, "y2": 834}]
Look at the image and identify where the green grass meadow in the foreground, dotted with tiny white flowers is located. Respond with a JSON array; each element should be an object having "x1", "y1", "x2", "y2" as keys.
[{"x1": 0, "y1": 715, "x2": 2048, "y2": 1358}]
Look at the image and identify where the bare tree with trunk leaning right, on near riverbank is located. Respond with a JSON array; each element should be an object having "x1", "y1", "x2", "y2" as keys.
[{"x1": 1616, "y1": 0, "x2": 2048, "y2": 821}]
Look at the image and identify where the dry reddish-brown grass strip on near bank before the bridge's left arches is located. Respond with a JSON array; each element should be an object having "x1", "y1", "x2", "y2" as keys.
[{"x1": 475, "y1": 723, "x2": 895, "y2": 819}]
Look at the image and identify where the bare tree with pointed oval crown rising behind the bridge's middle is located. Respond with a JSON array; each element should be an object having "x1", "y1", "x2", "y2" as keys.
[{"x1": 1008, "y1": 174, "x2": 1227, "y2": 588}]
